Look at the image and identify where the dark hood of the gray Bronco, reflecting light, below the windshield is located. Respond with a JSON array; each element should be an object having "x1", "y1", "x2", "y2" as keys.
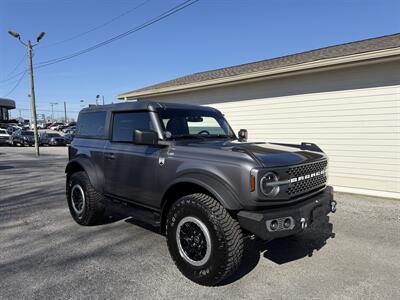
[{"x1": 177, "y1": 140, "x2": 326, "y2": 168}]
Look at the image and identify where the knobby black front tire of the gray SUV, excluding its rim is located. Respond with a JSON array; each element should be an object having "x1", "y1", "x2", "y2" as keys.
[{"x1": 166, "y1": 193, "x2": 244, "y2": 286}]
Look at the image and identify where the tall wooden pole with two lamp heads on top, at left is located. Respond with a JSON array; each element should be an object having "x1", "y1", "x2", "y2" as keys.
[{"x1": 8, "y1": 30, "x2": 45, "y2": 157}]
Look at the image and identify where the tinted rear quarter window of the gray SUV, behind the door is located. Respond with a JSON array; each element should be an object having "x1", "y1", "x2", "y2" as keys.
[{"x1": 76, "y1": 111, "x2": 106, "y2": 138}]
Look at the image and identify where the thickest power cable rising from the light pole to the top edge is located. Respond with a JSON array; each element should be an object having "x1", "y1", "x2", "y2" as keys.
[{"x1": 35, "y1": 0, "x2": 199, "y2": 68}]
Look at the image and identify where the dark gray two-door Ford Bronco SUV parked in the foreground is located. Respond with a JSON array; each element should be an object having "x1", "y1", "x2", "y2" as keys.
[{"x1": 65, "y1": 101, "x2": 336, "y2": 285}]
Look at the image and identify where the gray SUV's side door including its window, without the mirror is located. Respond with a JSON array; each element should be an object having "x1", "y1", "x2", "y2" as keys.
[{"x1": 104, "y1": 111, "x2": 160, "y2": 207}]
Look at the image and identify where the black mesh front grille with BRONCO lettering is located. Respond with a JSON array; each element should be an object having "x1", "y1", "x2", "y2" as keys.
[{"x1": 286, "y1": 160, "x2": 328, "y2": 198}]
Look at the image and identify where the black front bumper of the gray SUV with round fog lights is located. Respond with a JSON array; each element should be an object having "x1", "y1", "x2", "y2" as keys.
[{"x1": 237, "y1": 186, "x2": 336, "y2": 240}]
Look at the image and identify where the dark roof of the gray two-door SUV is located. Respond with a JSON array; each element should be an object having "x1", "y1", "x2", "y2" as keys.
[{"x1": 81, "y1": 101, "x2": 219, "y2": 112}]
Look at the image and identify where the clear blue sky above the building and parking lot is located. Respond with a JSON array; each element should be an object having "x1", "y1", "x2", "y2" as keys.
[{"x1": 0, "y1": 0, "x2": 400, "y2": 118}]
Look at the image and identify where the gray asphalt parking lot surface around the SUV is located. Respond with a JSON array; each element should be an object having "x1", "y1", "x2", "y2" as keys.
[{"x1": 0, "y1": 147, "x2": 400, "y2": 299}]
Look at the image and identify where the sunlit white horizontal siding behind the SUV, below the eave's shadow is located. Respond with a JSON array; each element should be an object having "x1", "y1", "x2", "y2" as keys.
[{"x1": 211, "y1": 86, "x2": 400, "y2": 198}]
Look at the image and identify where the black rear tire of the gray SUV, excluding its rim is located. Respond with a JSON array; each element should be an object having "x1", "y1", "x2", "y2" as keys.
[{"x1": 67, "y1": 171, "x2": 104, "y2": 226}]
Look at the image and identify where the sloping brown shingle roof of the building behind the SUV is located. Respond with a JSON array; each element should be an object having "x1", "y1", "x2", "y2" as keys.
[{"x1": 120, "y1": 33, "x2": 400, "y2": 97}]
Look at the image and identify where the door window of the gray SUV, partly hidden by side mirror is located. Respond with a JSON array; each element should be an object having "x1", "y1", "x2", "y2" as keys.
[{"x1": 112, "y1": 112, "x2": 154, "y2": 142}]
